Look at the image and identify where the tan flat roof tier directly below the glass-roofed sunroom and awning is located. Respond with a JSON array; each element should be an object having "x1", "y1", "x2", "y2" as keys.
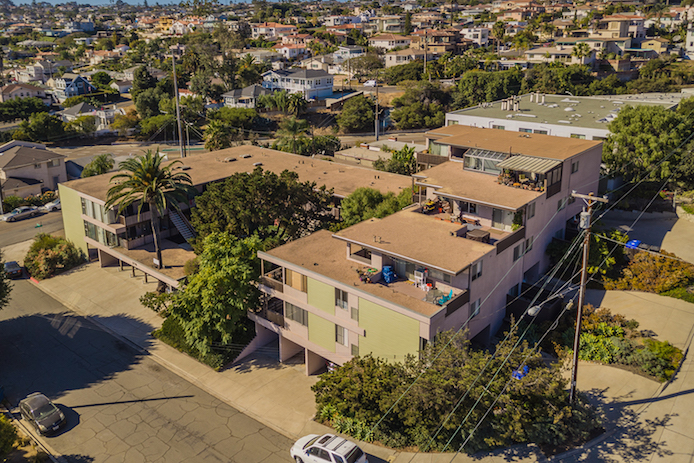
[{"x1": 415, "y1": 160, "x2": 544, "y2": 211}]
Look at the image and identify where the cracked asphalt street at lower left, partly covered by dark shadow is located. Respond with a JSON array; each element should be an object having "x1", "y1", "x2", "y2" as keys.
[{"x1": 0, "y1": 280, "x2": 292, "y2": 463}]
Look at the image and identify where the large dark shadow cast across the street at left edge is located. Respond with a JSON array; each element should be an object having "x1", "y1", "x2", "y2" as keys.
[{"x1": 0, "y1": 312, "x2": 152, "y2": 405}]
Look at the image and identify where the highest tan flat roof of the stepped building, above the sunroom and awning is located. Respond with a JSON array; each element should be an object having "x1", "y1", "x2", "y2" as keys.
[{"x1": 426, "y1": 125, "x2": 602, "y2": 160}]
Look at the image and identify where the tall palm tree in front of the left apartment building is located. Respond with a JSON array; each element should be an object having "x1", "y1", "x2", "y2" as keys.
[{"x1": 105, "y1": 150, "x2": 196, "y2": 268}]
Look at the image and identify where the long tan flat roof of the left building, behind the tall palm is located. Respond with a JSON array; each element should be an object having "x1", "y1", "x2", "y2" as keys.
[{"x1": 63, "y1": 145, "x2": 412, "y2": 201}]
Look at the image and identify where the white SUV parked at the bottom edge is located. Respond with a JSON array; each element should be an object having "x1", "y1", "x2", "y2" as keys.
[{"x1": 289, "y1": 434, "x2": 369, "y2": 463}]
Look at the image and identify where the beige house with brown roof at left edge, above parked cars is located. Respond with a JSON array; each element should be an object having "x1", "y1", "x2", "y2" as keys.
[{"x1": 0, "y1": 140, "x2": 67, "y2": 198}]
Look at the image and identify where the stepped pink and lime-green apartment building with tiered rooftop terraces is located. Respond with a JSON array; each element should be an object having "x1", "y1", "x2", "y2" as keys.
[{"x1": 249, "y1": 126, "x2": 602, "y2": 374}]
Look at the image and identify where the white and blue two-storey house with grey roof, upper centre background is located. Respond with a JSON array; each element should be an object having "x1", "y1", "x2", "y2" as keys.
[{"x1": 263, "y1": 69, "x2": 333, "y2": 100}]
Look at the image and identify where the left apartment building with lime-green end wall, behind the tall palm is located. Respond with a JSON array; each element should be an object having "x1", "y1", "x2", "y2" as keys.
[{"x1": 58, "y1": 142, "x2": 412, "y2": 288}]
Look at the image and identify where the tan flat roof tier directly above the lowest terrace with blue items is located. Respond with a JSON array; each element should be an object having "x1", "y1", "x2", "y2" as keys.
[{"x1": 335, "y1": 208, "x2": 494, "y2": 275}]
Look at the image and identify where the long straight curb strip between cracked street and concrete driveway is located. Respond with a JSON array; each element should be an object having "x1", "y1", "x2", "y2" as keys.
[{"x1": 30, "y1": 278, "x2": 305, "y2": 444}]
